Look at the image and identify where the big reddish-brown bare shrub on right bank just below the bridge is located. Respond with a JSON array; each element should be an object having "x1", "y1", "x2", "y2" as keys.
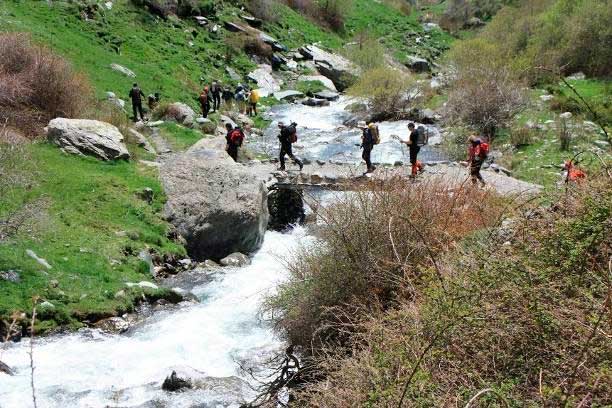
[{"x1": 266, "y1": 181, "x2": 501, "y2": 355}]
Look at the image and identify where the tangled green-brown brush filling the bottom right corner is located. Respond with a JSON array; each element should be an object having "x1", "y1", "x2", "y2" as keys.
[{"x1": 296, "y1": 177, "x2": 612, "y2": 408}]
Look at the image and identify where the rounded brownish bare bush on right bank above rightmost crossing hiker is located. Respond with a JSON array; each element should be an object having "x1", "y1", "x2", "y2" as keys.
[{"x1": 446, "y1": 64, "x2": 528, "y2": 139}]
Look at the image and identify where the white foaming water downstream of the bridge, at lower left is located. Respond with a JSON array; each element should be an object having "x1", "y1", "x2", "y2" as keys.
[{"x1": 0, "y1": 228, "x2": 312, "y2": 408}]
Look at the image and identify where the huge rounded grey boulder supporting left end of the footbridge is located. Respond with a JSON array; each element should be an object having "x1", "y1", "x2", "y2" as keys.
[{"x1": 160, "y1": 143, "x2": 268, "y2": 261}]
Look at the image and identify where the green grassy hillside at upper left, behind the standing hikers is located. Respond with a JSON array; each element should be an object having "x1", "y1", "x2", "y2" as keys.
[{"x1": 0, "y1": 0, "x2": 254, "y2": 108}]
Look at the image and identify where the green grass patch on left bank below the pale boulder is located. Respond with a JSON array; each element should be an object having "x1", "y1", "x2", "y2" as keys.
[{"x1": 0, "y1": 143, "x2": 185, "y2": 329}]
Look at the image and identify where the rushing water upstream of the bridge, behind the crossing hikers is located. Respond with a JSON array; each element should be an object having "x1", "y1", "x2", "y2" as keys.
[{"x1": 254, "y1": 96, "x2": 445, "y2": 164}]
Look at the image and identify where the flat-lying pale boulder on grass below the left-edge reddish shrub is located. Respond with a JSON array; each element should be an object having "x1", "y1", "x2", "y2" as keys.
[{"x1": 45, "y1": 118, "x2": 130, "y2": 160}]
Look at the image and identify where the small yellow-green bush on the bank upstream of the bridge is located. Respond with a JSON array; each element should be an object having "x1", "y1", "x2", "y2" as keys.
[{"x1": 348, "y1": 67, "x2": 417, "y2": 120}]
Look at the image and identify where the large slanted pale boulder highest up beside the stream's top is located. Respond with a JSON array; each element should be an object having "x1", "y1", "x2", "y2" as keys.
[{"x1": 300, "y1": 45, "x2": 360, "y2": 91}]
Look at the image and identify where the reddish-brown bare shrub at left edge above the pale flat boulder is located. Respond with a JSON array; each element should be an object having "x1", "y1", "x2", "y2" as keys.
[{"x1": 0, "y1": 33, "x2": 92, "y2": 136}]
